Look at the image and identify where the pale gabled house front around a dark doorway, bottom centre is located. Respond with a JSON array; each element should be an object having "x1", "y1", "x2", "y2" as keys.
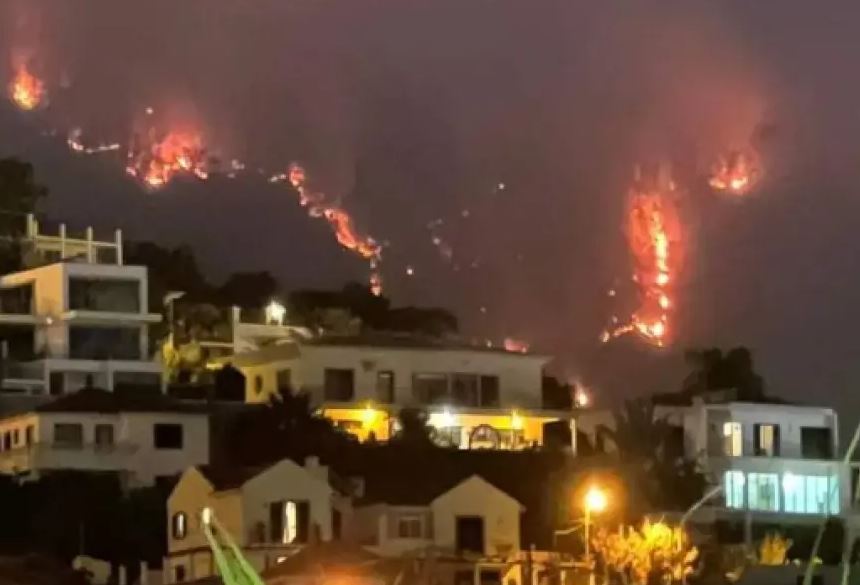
[{"x1": 430, "y1": 476, "x2": 522, "y2": 555}]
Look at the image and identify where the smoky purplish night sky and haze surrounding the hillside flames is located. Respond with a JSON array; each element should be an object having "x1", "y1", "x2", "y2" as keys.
[{"x1": 0, "y1": 0, "x2": 860, "y2": 428}]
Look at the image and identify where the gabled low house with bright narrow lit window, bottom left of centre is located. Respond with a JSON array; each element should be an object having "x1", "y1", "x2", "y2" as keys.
[{"x1": 164, "y1": 458, "x2": 350, "y2": 583}]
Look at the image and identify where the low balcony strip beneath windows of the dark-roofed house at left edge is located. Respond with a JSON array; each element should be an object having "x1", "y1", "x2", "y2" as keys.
[{"x1": 0, "y1": 443, "x2": 138, "y2": 474}]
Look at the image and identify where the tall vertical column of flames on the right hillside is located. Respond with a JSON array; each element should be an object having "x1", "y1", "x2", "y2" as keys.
[{"x1": 602, "y1": 164, "x2": 682, "y2": 346}]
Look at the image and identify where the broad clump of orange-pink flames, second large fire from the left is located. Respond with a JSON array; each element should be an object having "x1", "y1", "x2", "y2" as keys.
[{"x1": 126, "y1": 131, "x2": 209, "y2": 189}]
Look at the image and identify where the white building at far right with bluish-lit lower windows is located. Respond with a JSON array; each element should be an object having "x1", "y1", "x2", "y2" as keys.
[{"x1": 577, "y1": 398, "x2": 850, "y2": 520}]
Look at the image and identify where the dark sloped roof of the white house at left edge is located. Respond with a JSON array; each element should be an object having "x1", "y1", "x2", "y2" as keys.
[{"x1": 35, "y1": 388, "x2": 207, "y2": 414}]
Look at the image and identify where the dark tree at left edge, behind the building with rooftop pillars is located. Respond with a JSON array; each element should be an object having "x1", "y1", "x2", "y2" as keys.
[{"x1": 0, "y1": 158, "x2": 48, "y2": 274}]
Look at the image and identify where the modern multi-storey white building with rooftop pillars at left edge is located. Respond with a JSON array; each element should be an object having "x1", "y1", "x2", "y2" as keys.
[{"x1": 0, "y1": 212, "x2": 161, "y2": 395}]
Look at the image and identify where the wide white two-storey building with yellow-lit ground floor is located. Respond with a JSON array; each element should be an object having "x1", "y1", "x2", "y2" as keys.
[{"x1": 225, "y1": 334, "x2": 571, "y2": 449}]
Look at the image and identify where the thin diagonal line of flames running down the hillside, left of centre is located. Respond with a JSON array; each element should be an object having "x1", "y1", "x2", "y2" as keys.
[{"x1": 282, "y1": 163, "x2": 382, "y2": 295}]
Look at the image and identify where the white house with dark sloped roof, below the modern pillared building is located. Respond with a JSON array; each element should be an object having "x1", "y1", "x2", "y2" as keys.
[{"x1": 0, "y1": 388, "x2": 209, "y2": 486}]
